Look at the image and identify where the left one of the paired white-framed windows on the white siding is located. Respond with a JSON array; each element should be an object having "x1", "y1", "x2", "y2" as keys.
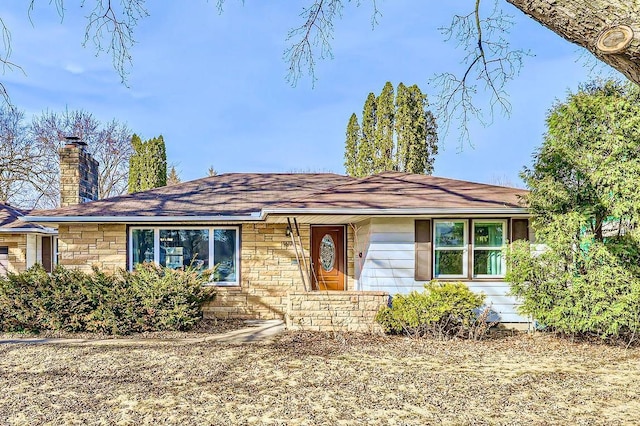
[{"x1": 433, "y1": 220, "x2": 468, "y2": 278}]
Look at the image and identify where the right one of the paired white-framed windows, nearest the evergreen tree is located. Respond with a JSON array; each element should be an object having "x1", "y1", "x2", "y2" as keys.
[{"x1": 473, "y1": 220, "x2": 507, "y2": 278}]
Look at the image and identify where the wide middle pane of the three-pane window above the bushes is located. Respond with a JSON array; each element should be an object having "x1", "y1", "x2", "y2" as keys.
[{"x1": 160, "y1": 229, "x2": 209, "y2": 270}]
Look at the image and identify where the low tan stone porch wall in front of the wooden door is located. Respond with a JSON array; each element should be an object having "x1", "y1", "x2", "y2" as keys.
[{"x1": 286, "y1": 291, "x2": 389, "y2": 333}]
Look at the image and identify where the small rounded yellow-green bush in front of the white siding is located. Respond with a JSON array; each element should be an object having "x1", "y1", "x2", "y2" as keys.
[{"x1": 376, "y1": 281, "x2": 488, "y2": 338}]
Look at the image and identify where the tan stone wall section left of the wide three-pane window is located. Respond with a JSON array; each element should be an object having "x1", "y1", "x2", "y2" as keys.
[{"x1": 58, "y1": 223, "x2": 127, "y2": 272}]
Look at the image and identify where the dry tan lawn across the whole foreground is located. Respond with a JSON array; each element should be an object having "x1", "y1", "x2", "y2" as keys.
[{"x1": 0, "y1": 333, "x2": 640, "y2": 425}]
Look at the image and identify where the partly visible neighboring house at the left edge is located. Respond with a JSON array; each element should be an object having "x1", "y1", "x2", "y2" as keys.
[{"x1": 0, "y1": 203, "x2": 57, "y2": 275}]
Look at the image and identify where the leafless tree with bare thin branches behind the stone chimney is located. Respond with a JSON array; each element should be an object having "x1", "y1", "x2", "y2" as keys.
[{"x1": 0, "y1": 108, "x2": 133, "y2": 208}]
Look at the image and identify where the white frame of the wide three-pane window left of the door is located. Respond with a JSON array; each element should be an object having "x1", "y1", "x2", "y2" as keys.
[{"x1": 127, "y1": 225, "x2": 240, "y2": 287}]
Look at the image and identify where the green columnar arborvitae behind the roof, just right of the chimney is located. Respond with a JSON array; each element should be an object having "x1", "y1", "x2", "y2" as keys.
[{"x1": 129, "y1": 135, "x2": 167, "y2": 193}]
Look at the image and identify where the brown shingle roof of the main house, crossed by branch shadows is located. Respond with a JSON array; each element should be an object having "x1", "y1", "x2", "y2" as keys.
[{"x1": 23, "y1": 172, "x2": 527, "y2": 217}]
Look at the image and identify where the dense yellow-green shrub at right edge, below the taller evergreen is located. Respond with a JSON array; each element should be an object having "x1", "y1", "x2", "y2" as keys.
[{"x1": 506, "y1": 241, "x2": 640, "y2": 340}]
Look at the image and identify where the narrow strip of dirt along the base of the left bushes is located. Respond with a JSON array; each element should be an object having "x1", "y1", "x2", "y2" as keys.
[{"x1": 0, "y1": 318, "x2": 248, "y2": 340}]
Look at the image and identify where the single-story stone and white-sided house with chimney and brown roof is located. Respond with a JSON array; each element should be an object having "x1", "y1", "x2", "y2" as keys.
[{"x1": 24, "y1": 144, "x2": 529, "y2": 330}]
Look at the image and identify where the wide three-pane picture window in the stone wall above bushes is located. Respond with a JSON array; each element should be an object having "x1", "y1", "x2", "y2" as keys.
[{"x1": 129, "y1": 227, "x2": 239, "y2": 285}]
